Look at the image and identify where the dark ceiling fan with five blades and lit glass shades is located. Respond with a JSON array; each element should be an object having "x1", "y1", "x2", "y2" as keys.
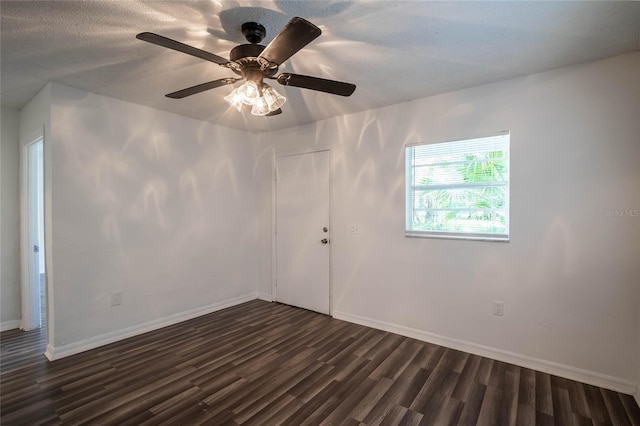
[{"x1": 136, "y1": 17, "x2": 356, "y2": 116}]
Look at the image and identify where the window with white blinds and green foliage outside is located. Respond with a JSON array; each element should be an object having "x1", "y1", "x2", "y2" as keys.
[{"x1": 405, "y1": 133, "x2": 509, "y2": 241}]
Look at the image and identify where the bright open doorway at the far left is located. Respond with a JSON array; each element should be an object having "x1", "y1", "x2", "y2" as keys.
[{"x1": 21, "y1": 138, "x2": 47, "y2": 331}]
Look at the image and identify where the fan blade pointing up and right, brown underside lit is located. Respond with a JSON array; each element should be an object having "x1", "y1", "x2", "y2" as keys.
[{"x1": 260, "y1": 17, "x2": 322, "y2": 65}]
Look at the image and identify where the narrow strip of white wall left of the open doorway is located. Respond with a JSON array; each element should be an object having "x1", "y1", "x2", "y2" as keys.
[{"x1": 0, "y1": 108, "x2": 21, "y2": 331}]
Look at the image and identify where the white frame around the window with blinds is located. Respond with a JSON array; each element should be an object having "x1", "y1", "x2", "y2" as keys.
[{"x1": 405, "y1": 131, "x2": 511, "y2": 242}]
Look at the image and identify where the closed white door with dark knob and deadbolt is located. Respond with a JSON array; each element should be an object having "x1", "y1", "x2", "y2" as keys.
[{"x1": 276, "y1": 151, "x2": 331, "y2": 315}]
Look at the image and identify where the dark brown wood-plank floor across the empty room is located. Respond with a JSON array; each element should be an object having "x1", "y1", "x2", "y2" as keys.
[{"x1": 0, "y1": 300, "x2": 640, "y2": 426}]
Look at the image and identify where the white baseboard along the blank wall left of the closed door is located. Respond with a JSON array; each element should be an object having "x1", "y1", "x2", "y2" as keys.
[{"x1": 45, "y1": 293, "x2": 258, "y2": 361}]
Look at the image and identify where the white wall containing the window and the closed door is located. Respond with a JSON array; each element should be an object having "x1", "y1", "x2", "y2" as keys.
[{"x1": 258, "y1": 53, "x2": 640, "y2": 392}]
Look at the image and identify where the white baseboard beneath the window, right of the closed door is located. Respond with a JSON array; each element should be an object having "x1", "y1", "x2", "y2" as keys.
[{"x1": 333, "y1": 311, "x2": 640, "y2": 396}]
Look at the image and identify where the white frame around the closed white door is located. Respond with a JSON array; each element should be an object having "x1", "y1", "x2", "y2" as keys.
[{"x1": 271, "y1": 145, "x2": 336, "y2": 317}]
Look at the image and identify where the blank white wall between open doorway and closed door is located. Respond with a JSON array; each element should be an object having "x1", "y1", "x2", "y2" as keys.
[{"x1": 48, "y1": 84, "x2": 258, "y2": 349}]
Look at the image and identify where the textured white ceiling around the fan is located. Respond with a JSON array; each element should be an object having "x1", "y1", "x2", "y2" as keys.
[{"x1": 0, "y1": 0, "x2": 640, "y2": 131}]
